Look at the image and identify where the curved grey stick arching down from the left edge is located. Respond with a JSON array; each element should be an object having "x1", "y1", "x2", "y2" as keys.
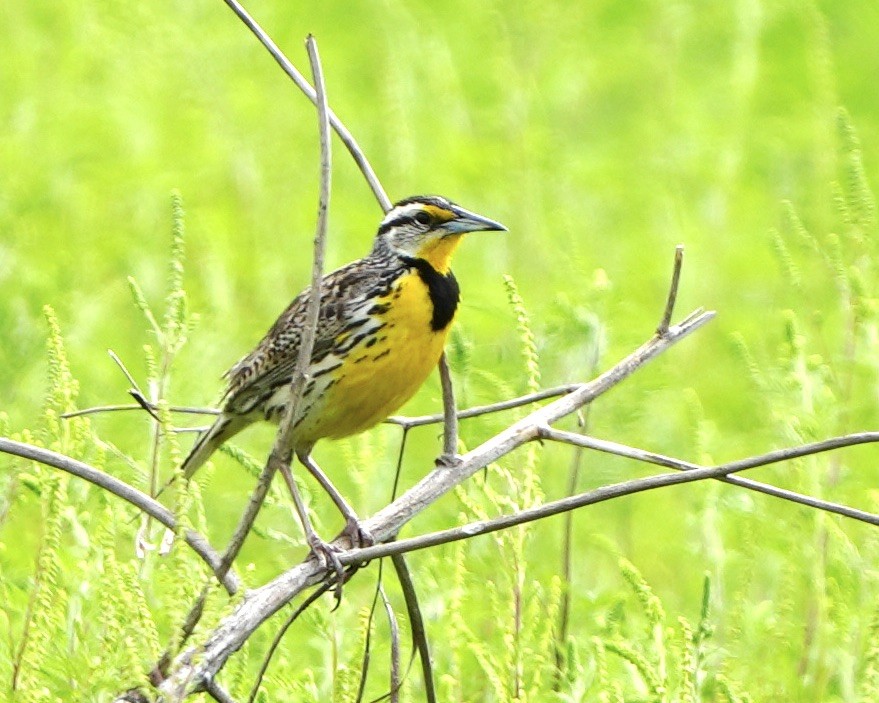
[{"x1": 0, "y1": 437, "x2": 240, "y2": 595}]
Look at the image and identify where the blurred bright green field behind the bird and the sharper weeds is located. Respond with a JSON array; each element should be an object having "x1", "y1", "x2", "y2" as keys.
[{"x1": 0, "y1": 0, "x2": 879, "y2": 701}]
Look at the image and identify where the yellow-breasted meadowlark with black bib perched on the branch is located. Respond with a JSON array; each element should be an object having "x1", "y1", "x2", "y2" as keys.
[{"x1": 181, "y1": 195, "x2": 507, "y2": 556}]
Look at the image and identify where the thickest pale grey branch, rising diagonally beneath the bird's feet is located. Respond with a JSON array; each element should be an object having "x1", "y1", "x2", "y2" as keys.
[{"x1": 155, "y1": 312, "x2": 714, "y2": 697}]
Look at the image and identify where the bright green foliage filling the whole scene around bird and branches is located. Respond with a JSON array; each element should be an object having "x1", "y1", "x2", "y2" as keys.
[{"x1": 0, "y1": 0, "x2": 879, "y2": 703}]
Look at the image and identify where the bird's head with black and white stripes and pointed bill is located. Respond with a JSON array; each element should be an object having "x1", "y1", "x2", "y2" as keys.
[{"x1": 376, "y1": 195, "x2": 507, "y2": 274}]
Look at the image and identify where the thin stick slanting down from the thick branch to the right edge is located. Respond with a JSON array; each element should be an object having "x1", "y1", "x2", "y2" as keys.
[{"x1": 542, "y1": 427, "x2": 879, "y2": 526}]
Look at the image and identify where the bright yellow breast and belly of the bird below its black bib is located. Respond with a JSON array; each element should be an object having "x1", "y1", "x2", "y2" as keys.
[{"x1": 297, "y1": 271, "x2": 451, "y2": 441}]
